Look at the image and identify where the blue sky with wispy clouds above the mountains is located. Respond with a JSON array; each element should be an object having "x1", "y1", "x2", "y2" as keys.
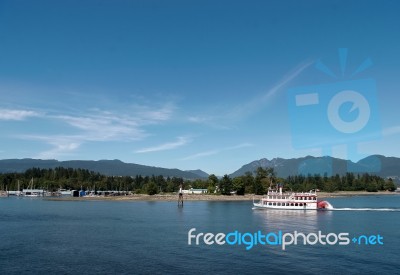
[{"x1": 0, "y1": 0, "x2": 400, "y2": 175}]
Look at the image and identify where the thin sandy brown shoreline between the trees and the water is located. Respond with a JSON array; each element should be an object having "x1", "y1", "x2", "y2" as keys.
[{"x1": 45, "y1": 191, "x2": 399, "y2": 202}]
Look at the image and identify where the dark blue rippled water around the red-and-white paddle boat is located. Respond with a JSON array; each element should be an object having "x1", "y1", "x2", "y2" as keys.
[{"x1": 0, "y1": 195, "x2": 400, "y2": 274}]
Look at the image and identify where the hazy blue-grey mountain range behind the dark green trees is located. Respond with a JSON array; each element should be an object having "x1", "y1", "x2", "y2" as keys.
[{"x1": 0, "y1": 155, "x2": 400, "y2": 182}]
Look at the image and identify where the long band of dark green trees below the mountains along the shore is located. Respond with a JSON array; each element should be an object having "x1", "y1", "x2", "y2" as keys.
[{"x1": 0, "y1": 167, "x2": 396, "y2": 195}]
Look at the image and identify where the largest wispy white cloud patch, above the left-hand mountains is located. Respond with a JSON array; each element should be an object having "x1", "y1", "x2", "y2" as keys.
[{"x1": 15, "y1": 99, "x2": 175, "y2": 158}]
